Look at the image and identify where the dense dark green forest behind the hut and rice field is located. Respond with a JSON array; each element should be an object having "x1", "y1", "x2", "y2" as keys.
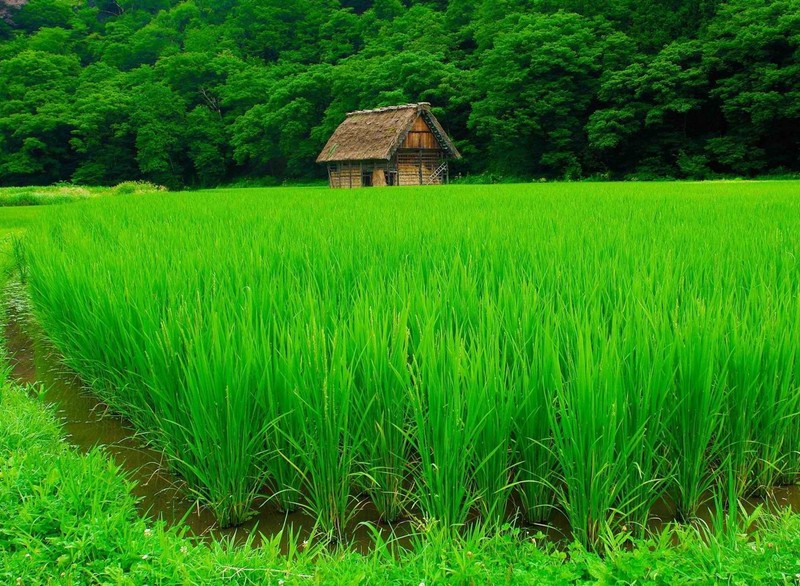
[{"x1": 0, "y1": 0, "x2": 800, "y2": 189}]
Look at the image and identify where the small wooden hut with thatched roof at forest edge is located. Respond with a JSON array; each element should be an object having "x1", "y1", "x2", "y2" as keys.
[{"x1": 317, "y1": 102, "x2": 461, "y2": 188}]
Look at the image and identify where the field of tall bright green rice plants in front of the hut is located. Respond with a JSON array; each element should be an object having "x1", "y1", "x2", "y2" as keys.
[{"x1": 15, "y1": 182, "x2": 800, "y2": 547}]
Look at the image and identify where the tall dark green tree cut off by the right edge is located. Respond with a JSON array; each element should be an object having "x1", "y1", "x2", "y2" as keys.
[{"x1": 704, "y1": 0, "x2": 800, "y2": 174}]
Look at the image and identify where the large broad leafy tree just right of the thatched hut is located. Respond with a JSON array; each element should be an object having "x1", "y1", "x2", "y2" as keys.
[{"x1": 469, "y1": 12, "x2": 631, "y2": 177}]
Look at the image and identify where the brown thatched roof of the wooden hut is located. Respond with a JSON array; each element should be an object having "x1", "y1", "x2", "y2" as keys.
[{"x1": 317, "y1": 102, "x2": 461, "y2": 163}]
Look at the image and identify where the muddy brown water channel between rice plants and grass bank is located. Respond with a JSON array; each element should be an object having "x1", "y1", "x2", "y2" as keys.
[{"x1": 4, "y1": 283, "x2": 800, "y2": 552}]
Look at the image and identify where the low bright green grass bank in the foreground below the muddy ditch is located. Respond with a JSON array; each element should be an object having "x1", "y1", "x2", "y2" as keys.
[{"x1": 0, "y1": 181, "x2": 800, "y2": 584}]
